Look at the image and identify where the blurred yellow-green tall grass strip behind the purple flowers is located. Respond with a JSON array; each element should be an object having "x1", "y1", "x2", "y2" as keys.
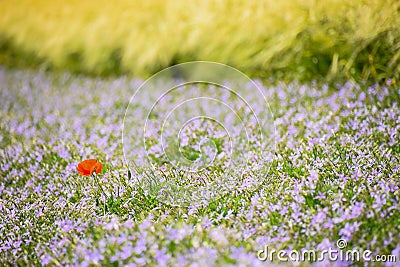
[{"x1": 0, "y1": 0, "x2": 400, "y2": 82}]
